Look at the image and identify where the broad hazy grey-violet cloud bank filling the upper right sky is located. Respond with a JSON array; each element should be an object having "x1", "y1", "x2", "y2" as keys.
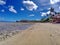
[{"x1": 35, "y1": 0, "x2": 60, "y2": 12}]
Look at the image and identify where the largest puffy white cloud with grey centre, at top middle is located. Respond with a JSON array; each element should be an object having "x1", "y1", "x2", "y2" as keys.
[{"x1": 23, "y1": 0, "x2": 38, "y2": 11}]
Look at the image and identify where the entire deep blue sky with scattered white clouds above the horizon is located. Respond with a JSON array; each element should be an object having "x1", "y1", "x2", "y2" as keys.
[{"x1": 0, "y1": 0, "x2": 60, "y2": 21}]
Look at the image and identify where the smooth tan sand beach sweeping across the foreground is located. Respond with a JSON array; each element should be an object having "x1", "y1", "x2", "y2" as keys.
[{"x1": 0, "y1": 23, "x2": 60, "y2": 45}]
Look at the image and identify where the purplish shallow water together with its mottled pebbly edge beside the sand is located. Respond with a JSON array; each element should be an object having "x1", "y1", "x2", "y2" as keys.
[{"x1": 0, "y1": 22, "x2": 33, "y2": 42}]
